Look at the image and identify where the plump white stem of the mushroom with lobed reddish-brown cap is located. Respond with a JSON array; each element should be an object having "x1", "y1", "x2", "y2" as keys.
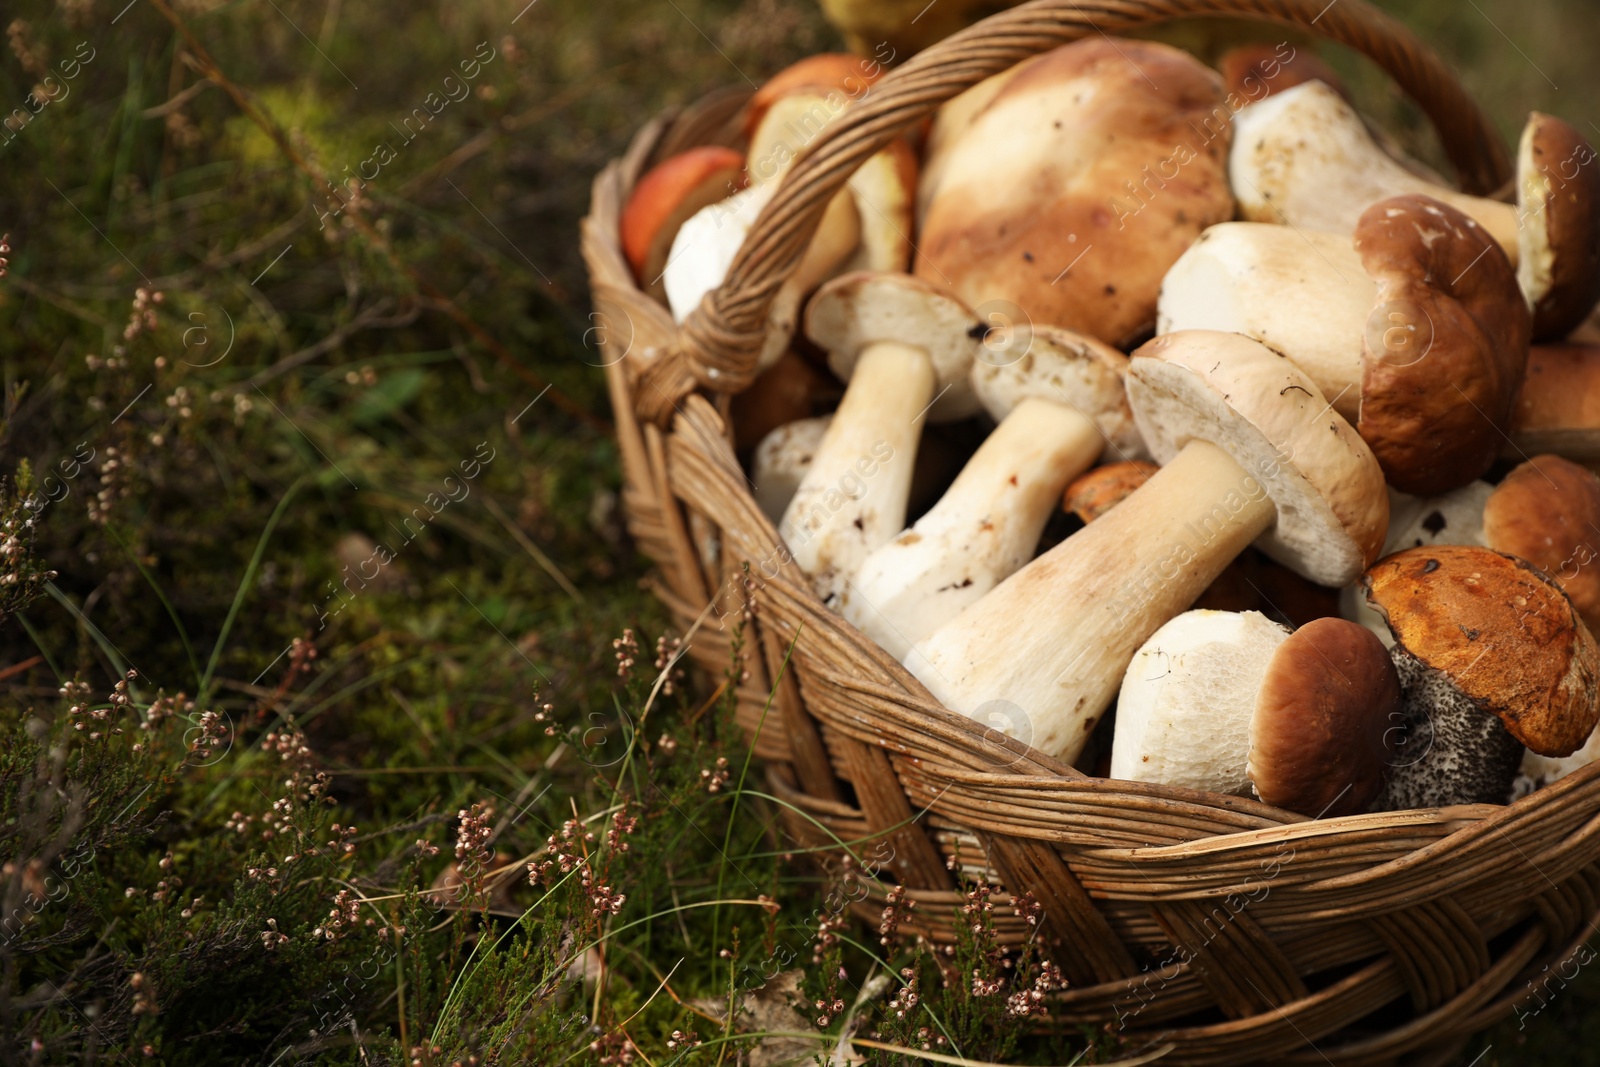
[{"x1": 1155, "y1": 225, "x2": 1369, "y2": 422}]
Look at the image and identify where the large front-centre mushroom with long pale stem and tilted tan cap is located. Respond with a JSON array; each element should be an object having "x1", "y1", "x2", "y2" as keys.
[{"x1": 906, "y1": 331, "x2": 1389, "y2": 760}]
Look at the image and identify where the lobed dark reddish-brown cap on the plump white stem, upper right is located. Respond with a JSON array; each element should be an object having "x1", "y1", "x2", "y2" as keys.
[{"x1": 1355, "y1": 195, "x2": 1530, "y2": 496}]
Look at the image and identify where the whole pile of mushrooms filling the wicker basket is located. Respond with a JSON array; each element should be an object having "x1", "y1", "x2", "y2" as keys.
[{"x1": 622, "y1": 35, "x2": 1600, "y2": 817}]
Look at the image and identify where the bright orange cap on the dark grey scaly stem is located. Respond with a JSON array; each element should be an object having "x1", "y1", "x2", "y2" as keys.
[{"x1": 1363, "y1": 545, "x2": 1600, "y2": 755}]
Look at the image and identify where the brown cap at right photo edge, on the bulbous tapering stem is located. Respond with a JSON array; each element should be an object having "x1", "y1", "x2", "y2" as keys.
[{"x1": 1517, "y1": 112, "x2": 1600, "y2": 339}]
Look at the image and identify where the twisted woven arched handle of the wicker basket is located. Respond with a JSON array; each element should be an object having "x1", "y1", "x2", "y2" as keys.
[{"x1": 634, "y1": 0, "x2": 1510, "y2": 424}]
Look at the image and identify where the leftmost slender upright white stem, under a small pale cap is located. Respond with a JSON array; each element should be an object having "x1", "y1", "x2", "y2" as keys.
[{"x1": 779, "y1": 341, "x2": 934, "y2": 603}]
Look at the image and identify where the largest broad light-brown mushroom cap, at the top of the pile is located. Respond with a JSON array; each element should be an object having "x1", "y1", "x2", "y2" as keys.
[{"x1": 915, "y1": 37, "x2": 1234, "y2": 346}]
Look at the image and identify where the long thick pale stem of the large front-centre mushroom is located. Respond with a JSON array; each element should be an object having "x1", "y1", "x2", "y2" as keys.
[{"x1": 906, "y1": 440, "x2": 1277, "y2": 761}]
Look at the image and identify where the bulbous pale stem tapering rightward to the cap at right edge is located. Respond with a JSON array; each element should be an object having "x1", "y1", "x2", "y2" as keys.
[{"x1": 1229, "y1": 82, "x2": 1518, "y2": 266}]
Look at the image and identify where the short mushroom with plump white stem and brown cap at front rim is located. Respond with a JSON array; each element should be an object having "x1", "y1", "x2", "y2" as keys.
[{"x1": 1110, "y1": 611, "x2": 1400, "y2": 817}]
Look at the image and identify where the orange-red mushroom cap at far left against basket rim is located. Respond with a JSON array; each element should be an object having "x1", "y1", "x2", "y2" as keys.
[{"x1": 619, "y1": 144, "x2": 744, "y2": 304}]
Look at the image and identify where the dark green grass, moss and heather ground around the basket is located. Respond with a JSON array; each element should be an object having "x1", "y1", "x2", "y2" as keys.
[{"x1": 0, "y1": 0, "x2": 1600, "y2": 1064}]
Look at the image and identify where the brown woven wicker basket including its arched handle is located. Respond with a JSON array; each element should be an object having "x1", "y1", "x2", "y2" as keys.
[{"x1": 582, "y1": 0, "x2": 1600, "y2": 1064}]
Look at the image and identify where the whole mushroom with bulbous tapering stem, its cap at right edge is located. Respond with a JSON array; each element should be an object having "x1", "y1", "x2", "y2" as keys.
[{"x1": 1229, "y1": 82, "x2": 1600, "y2": 338}]
